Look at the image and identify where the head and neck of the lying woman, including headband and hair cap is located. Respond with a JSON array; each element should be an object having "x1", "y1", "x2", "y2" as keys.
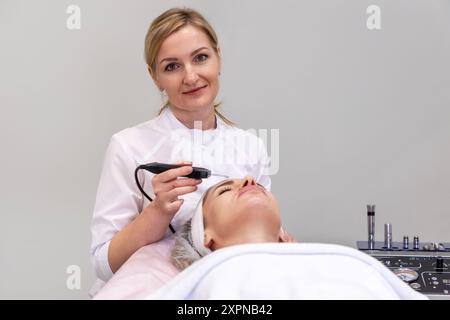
[{"x1": 172, "y1": 177, "x2": 295, "y2": 270}]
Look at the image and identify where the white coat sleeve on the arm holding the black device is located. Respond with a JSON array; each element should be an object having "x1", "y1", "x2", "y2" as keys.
[{"x1": 90, "y1": 134, "x2": 143, "y2": 281}]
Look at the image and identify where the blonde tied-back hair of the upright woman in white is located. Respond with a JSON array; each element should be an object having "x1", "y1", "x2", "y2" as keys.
[{"x1": 144, "y1": 8, "x2": 234, "y2": 126}]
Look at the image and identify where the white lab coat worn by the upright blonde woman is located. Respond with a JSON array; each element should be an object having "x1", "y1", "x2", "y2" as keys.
[{"x1": 90, "y1": 108, "x2": 271, "y2": 296}]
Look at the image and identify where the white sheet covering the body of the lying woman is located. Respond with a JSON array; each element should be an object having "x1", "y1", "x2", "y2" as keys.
[{"x1": 147, "y1": 243, "x2": 427, "y2": 299}]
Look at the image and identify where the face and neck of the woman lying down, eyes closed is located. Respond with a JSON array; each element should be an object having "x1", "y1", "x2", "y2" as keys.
[{"x1": 203, "y1": 177, "x2": 281, "y2": 250}]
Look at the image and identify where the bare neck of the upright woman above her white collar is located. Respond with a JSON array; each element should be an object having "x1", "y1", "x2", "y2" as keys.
[{"x1": 169, "y1": 105, "x2": 217, "y2": 130}]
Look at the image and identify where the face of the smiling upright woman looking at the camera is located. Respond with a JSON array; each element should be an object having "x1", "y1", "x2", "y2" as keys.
[{"x1": 153, "y1": 25, "x2": 221, "y2": 111}]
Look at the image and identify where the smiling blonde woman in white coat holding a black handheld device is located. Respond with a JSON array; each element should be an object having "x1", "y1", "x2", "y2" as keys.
[{"x1": 90, "y1": 8, "x2": 271, "y2": 294}]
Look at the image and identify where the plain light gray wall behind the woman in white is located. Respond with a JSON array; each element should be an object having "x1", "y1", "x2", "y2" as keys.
[{"x1": 0, "y1": 0, "x2": 450, "y2": 299}]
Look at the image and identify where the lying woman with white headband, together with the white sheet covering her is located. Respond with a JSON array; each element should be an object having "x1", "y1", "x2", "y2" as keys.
[{"x1": 147, "y1": 177, "x2": 427, "y2": 299}]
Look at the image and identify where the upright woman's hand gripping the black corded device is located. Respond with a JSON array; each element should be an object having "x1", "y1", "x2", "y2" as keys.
[{"x1": 151, "y1": 161, "x2": 202, "y2": 217}]
